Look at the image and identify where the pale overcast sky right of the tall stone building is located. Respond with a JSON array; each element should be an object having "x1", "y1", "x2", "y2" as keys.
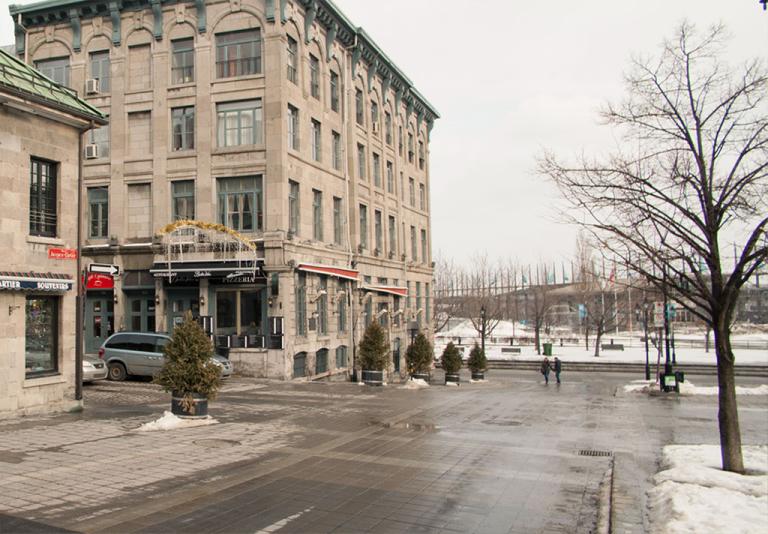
[{"x1": 0, "y1": 0, "x2": 768, "y2": 263}]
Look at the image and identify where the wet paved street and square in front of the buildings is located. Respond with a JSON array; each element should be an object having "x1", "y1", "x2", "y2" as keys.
[{"x1": 0, "y1": 370, "x2": 768, "y2": 533}]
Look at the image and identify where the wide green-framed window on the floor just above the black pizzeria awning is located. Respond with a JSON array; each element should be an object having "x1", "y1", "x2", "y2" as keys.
[{"x1": 218, "y1": 175, "x2": 263, "y2": 232}]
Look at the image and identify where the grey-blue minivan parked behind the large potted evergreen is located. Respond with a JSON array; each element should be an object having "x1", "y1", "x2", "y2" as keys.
[{"x1": 99, "y1": 332, "x2": 232, "y2": 381}]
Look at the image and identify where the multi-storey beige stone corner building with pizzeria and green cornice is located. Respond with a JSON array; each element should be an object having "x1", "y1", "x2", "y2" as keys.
[{"x1": 10, "y1": 0, "x2": 438, "y2": 379}]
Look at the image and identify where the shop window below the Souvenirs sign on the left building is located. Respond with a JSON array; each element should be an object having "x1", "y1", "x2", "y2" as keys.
[{"x1": 24, "y1": 295, "x2": 60, "y2": 377}]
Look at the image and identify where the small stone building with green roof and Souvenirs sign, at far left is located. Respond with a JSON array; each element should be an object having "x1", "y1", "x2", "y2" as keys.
[{"x1": 0, "y1": 50, "x2": 106, "y2": 417}]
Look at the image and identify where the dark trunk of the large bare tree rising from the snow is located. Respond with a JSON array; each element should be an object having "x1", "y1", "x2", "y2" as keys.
[{"x1": 713, "y1": 320, "x2": 744, "y2": 473}]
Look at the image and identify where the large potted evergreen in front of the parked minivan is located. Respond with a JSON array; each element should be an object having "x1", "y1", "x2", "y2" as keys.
[{"x1": 154, "y1": 312, "x2": 221, "y2": 417}]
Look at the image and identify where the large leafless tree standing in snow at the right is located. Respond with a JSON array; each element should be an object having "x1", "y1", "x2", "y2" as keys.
[{"x1": 539, "y1": 23, "x2": 768, "y2": 472}]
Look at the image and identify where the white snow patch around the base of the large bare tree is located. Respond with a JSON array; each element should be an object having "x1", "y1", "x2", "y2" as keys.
[{"x1": 648, "y1": 445, "x2": 768, "y2": 534}]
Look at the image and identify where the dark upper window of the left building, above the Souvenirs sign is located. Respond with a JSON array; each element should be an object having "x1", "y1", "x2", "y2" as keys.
[{"x1": 29, "y1": 158, "x2": 58, "y2": 237}]
